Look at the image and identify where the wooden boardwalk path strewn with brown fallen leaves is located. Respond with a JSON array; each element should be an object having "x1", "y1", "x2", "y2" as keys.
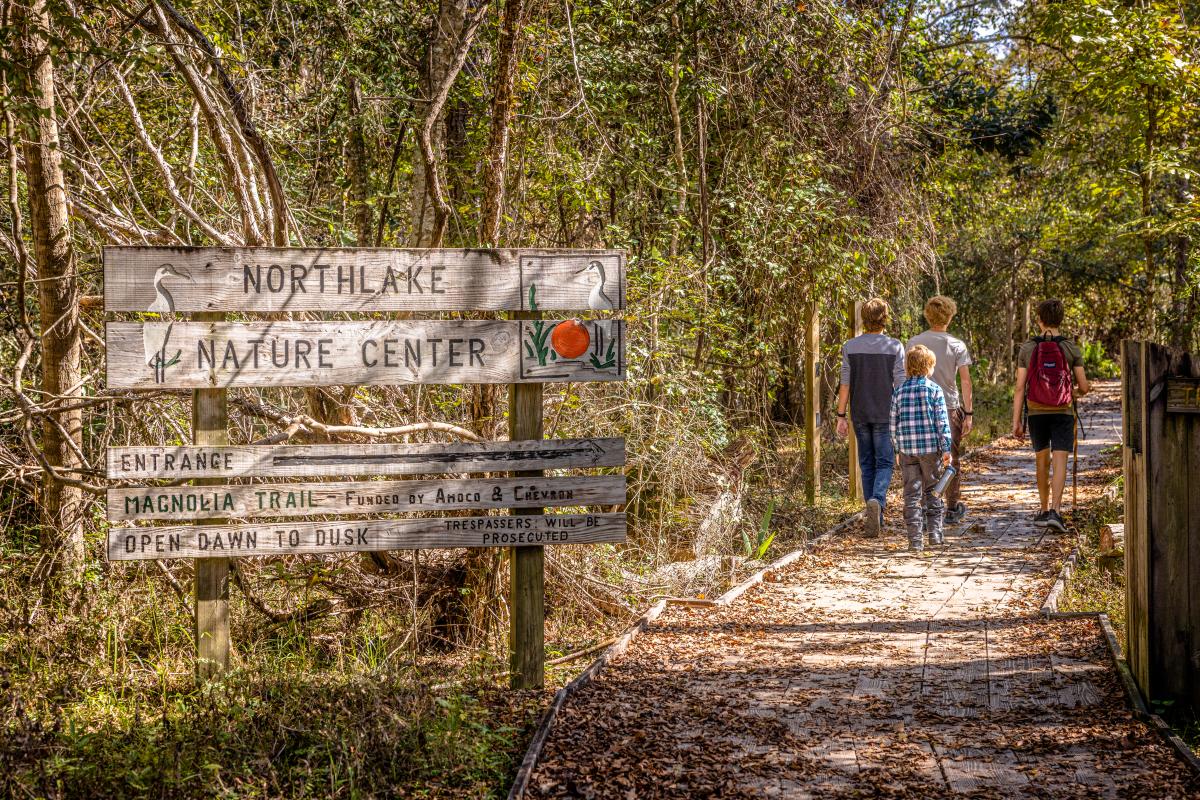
[{"x1": 529, "y1": 386, "x2": 1200, "y2": 799}]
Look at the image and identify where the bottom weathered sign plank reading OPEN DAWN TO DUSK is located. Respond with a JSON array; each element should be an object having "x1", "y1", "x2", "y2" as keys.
[{"x1": 108, "y1": 513, "x2": 625, "y2": 561}]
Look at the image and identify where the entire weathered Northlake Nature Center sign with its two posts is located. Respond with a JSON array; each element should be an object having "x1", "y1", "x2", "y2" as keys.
[{"x1": 104, "y1": 247, "x2": 625, "y2": 687}]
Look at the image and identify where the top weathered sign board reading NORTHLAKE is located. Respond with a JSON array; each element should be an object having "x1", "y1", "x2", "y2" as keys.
[{"x1": 104, "y1": 247, "x2": 625, "y2": 313}]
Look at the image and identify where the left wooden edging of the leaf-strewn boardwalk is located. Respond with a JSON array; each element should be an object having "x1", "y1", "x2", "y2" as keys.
[{"x1": 509, "y1": 511, "x2": 863, "y2": 800}]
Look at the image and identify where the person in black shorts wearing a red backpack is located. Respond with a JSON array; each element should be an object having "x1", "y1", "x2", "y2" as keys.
[{"x1": 1013, "y1": 300, "x2": 1092, "y2": 531}]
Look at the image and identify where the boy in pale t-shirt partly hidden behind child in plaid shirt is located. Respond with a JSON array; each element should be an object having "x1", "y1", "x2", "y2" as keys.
[{"x1": 905, "y1": 295, "x2": 974, "y2": 525}]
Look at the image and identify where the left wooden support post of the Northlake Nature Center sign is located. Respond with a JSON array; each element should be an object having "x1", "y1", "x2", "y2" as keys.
[{"x1": 192, "y1": 313, "x2": 230, "y2": 684}]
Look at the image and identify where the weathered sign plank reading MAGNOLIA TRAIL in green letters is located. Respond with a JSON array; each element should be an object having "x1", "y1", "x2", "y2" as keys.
[{"x1": 108, "y1": 475, "x2": 625, "y2": 522}]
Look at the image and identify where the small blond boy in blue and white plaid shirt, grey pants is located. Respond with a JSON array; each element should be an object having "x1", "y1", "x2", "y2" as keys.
[{"x1": 892, "y1": 344, "x2": 950, "y2": 553}]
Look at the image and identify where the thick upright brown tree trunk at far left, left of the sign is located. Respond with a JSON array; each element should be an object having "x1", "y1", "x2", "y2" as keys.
[{"x1": 18, "y1": 0, "x2": 84, "y2": 584}]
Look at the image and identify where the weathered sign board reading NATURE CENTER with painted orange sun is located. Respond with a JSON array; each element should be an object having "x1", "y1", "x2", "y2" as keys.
[{"x1": 104, "y1": 319, "x2": 625, "y2": 389}]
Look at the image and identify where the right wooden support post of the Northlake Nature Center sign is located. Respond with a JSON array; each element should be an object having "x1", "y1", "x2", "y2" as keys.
[{"x1": 509, "y1": 311, "x2": 546, "y2": 688}]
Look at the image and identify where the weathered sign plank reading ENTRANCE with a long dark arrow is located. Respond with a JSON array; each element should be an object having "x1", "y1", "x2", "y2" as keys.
[{"x1": 108, "y1": 439, "x2": 625, "y2": 481}]
